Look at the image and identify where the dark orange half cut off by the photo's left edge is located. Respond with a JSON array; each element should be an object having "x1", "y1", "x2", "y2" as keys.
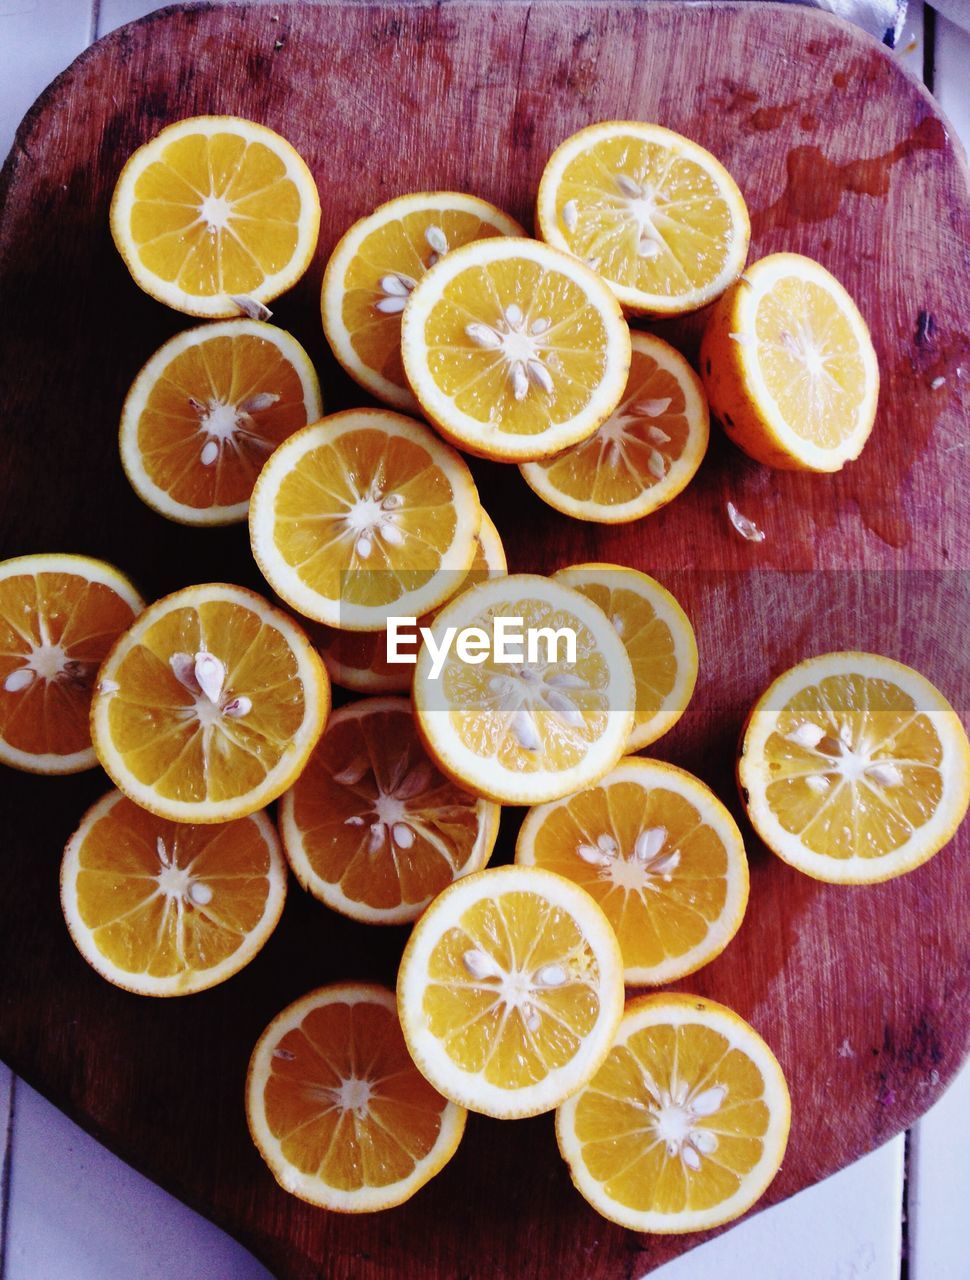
[{"x1": 0, "y1": 556, "x2": 145, "y2": 773}]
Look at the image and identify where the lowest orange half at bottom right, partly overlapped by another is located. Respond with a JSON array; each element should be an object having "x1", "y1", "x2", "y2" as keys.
[{"x1": 555, "y1": 993, "x2": 791, "y2": 1234}]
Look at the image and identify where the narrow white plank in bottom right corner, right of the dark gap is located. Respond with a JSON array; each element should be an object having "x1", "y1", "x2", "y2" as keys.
[{"x1": 909, "y1": 1064, "x2": 970, "y2": 1280}]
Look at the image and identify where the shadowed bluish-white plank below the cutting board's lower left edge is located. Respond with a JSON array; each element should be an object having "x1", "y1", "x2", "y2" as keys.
[{"x1": 3, "y1": 1080, "x2": 273, "y2": 1280}]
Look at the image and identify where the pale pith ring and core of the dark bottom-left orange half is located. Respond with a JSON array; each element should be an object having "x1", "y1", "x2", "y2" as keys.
[{"x1": 246, "y1": 983, "x2": 466, "y2": 1213}]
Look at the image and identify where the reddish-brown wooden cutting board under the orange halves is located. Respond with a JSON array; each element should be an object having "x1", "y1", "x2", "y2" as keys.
[{"x1": 0, "y1": 0, "x2": 970, "y2": 1280}]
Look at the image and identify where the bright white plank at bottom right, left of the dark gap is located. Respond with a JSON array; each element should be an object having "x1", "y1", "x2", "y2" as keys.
[{"x1": 650, "y1": 1137, "x2": 906, "y2": 1280}]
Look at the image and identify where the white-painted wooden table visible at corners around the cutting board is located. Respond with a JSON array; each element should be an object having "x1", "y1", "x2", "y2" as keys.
[{"x1": 0, "y1": 0, "x2": 970, "y2": 1280}]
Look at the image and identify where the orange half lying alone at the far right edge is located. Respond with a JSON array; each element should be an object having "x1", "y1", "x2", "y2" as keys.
[{"x1": 737, "y1": 653, "x2": 970, "y2": 884}]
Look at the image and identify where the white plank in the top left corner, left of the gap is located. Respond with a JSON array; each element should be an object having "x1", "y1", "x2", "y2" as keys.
[{"x1": 0, "y1": 0, "x2": 92, "y2": 159}]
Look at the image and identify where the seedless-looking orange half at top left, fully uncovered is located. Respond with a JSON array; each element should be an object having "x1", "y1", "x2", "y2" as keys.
[{"x1": 111, "y1": 115, "x2": 320, "y2": 317}]
